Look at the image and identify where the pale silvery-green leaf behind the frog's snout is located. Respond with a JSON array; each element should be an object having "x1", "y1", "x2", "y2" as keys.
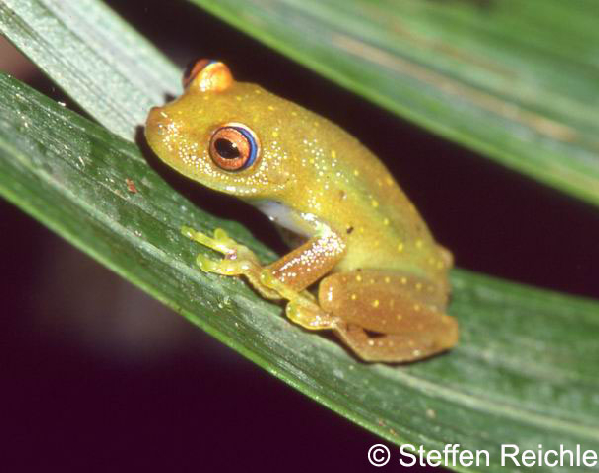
[{"x1": 0, "y1": 0, "x2": 181, "y2": 139}]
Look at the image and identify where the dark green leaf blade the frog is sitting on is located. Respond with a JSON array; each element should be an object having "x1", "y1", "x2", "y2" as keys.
[{"x1": 0, "y1": 74, "x2": 599, "y2": 472}]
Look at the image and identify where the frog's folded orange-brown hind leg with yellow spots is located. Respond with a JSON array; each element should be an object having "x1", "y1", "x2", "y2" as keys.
[{"x1": 319, "y1": 271, "x2": 458, "y2": 361}]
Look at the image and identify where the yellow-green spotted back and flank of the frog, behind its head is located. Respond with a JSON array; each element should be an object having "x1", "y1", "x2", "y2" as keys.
[{"x1": 252, "y1": 94, "x2": 451, "y2": 277}]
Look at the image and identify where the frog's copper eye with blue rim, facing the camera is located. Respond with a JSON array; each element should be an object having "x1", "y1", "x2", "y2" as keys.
[{"x1": 208, "y1": 123, "x2": 259, "y2": 171}]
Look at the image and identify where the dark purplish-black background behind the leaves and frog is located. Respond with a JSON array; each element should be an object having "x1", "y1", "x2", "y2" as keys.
[{"x1": 0, "y1": 0, "x2": 599, "y2": 471}]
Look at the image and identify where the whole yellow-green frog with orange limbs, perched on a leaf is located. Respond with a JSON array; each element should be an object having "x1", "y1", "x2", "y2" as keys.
[{"x1": 145, "y1": 60, "x2": 458, "y2": 362}]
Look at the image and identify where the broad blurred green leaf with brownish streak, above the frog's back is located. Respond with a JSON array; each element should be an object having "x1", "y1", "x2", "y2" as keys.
[{"x1": 192, "y1": 0, "x2": 599, "y2": 205}]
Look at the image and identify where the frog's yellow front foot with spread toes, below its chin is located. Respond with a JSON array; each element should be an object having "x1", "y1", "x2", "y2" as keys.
[{"x1": 181, "y1": 226, "x2": 281, "y2": 299}]
